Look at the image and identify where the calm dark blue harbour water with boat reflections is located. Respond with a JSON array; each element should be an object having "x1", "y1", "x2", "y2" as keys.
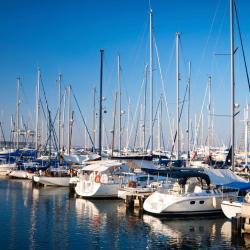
[{"x1": 0, "y1": 179, "x2": 250, "y2": 249}]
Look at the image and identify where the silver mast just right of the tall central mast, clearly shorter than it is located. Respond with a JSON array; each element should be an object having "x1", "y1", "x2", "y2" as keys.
[{"x1": 176, "y1": 32, "x2": 180, "y2": 160}]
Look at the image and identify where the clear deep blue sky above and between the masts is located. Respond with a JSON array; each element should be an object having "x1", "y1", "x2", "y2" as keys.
[{"x1": 0, "y1": 0, "x2": 250, "y2": 148}]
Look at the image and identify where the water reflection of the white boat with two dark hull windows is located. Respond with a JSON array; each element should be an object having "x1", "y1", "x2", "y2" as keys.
[{"x1": 143, "y1": 214, "x2": 231, "y2": 249}]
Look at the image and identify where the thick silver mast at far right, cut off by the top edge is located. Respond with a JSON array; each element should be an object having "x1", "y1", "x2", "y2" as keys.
[{"x1": 230, "y1": 0, "x2": 235, "y2": 171}]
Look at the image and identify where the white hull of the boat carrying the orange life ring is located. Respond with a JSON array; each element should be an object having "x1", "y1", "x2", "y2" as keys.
[{"x1": 75, "y1": 180, "x2": 120, "y2": 198}]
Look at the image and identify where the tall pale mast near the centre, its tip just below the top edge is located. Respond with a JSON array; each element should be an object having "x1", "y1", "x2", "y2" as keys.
[{"x1": 149, "y1": 8, "x2": 154, "y2": 153}]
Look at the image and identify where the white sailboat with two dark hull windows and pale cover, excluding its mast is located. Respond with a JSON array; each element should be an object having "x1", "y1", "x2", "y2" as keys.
[{"x1": 143, "y1": 169, "x2": 242, "y2": 215}]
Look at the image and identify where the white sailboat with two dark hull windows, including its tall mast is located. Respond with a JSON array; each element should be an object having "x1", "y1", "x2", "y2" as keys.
[{"x1": 143, "y1": 0, "x2": 250, "y2": 215}]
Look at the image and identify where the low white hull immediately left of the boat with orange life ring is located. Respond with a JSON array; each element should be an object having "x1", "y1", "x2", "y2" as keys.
[{"x1": 33, "y1": 176, "x2": 70, "y2": 187}]
